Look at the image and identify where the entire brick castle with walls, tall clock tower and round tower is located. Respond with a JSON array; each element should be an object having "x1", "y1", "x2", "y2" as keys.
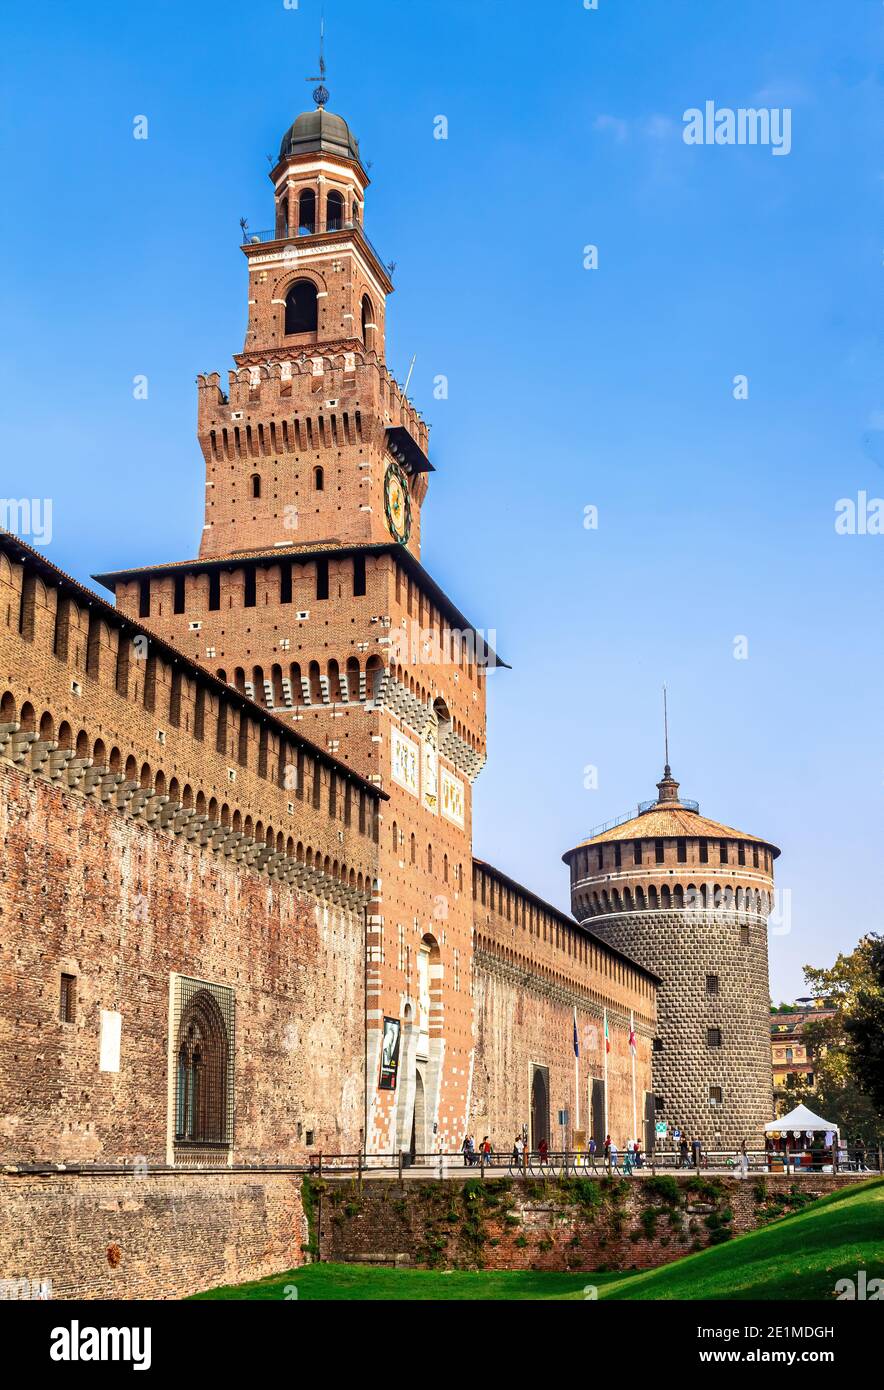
[{"x1": 0, "y1": 97, "x2": 776, "y2": 1297}]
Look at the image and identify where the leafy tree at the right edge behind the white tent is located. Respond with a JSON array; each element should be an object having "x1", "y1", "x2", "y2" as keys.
[{"x1": 785, "y1": 934, "x2": 884, "y2": 1141}]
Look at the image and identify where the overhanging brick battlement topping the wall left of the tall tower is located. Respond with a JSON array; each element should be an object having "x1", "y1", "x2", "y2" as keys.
[{"x1": 0, "y1": 532, "x2": 384, "y2": 906}]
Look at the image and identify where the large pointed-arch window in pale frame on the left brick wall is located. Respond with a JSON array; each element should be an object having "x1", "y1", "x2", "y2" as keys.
[{"x1": 175, "y1": 979, "x2": 232, "y2": 1145}]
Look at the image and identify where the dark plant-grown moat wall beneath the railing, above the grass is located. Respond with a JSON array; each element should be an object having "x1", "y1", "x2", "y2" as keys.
[{"x1": 320, "y1": 1175, "x2": 856, "y2": 1272}]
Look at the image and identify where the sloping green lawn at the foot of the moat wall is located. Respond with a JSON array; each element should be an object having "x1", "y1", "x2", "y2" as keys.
[{"x1": 195, "y1": 1179, "x2": 884, "y2": 1301}]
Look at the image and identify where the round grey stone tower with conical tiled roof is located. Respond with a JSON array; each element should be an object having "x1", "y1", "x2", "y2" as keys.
[{"x1": 563, "y1": 763, "x2": 780, "y2": 1150}]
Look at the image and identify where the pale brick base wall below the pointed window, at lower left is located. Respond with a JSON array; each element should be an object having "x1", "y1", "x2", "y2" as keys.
[{"x1": 0, "y1": 1172, "x2": 307, "y2": 1298}]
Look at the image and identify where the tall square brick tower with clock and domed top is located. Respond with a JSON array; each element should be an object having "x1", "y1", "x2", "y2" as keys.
[{"x1": 97, "y1": 88, "x2": 496, "y2": 1152}]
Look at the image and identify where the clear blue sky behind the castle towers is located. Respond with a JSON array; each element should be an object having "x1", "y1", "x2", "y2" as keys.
[{"x1": 0, "y1": 0, "x2": 884, "y2": 999}]
